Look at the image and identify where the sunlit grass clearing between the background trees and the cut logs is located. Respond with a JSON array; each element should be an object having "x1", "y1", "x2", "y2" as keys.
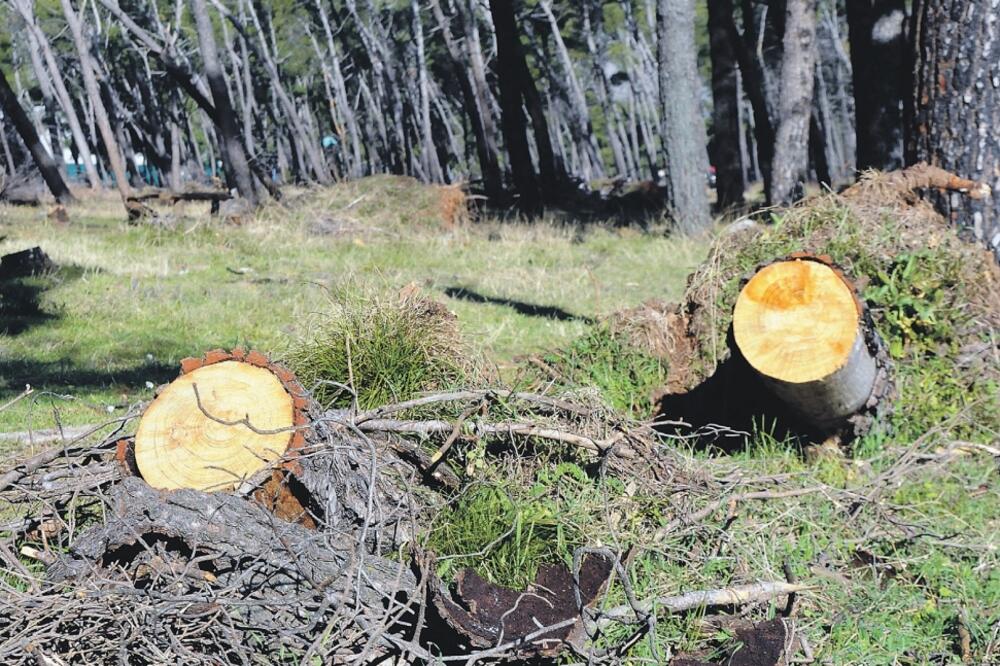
[{"x1": 0, "y1": 180, "x2": 705, "y2": 431}]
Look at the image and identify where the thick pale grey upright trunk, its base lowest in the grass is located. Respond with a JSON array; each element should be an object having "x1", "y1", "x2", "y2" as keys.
[{"x1": 657, "y1": 0, "x2": 712, "y2": 233}]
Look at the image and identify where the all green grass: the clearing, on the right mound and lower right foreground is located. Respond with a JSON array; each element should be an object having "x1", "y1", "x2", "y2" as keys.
[{"x1": 0, "y1": 180, "x2": 1000, "y2": 666}]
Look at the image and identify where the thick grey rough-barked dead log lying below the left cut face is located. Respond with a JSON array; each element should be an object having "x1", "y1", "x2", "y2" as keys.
[{"x1": 46, "y1": 478, "x2": 416, "y2": 614}]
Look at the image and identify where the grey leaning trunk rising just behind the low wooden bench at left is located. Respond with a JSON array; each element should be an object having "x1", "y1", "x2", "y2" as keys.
[{"x1": 188, "y1": 0, "x2": 257, "y2": 206}]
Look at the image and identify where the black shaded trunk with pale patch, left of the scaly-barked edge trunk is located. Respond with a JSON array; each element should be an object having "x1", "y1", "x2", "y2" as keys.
[{"x1": 847, "y1": 0, "x2": 909, "y2": 171}]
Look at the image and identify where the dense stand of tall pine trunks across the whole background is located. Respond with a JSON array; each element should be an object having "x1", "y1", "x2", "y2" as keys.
[{"x1": 0, "y1": 0, "x2": 997, "y2": 260}]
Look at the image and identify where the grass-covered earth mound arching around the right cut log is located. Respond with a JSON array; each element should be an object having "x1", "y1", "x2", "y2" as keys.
[{"x1": 628, "y1": 166, "x2": 1000, "y2": 440}]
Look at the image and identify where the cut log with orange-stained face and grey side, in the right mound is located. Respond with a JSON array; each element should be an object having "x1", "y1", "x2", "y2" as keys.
[{"x1": 733, "y1": 257, "x2": 878, "y2": 428}]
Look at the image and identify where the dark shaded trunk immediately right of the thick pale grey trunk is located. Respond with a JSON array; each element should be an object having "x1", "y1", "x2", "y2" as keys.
[{"x1": 708, "y1": 0, "x2": 745, "y2": 210}]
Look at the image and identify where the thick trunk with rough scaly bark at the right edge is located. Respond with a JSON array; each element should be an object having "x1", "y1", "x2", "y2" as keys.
[{"x1": 907, "y1": 0, "x2": 1000, "y2": 261}]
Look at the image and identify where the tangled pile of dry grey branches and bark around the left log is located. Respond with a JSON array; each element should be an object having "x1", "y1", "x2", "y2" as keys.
[{"x1": 0, "y1": 390, "x2": 804, "y2": 664}]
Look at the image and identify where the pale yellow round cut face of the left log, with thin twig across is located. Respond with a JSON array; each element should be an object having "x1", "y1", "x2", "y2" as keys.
[{"x1": 135, "y1": 360, "x2": 296, "y2": 491}]
